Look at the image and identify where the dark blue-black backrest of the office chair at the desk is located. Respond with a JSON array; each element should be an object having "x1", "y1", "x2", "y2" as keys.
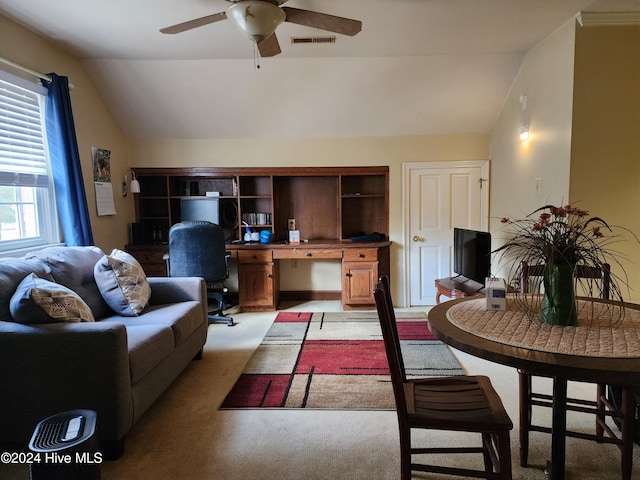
[{"x1": 169, "y1": 221, "x2": 228, "y2": 282}]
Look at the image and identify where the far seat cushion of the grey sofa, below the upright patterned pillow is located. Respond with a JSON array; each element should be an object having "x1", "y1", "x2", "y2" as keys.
[{"x1": 103, "y1": 301, "x2": 202, "y2": 346}]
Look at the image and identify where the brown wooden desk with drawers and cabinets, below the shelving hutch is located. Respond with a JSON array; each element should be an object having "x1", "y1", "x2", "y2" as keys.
[{"x1": 126, "y1": 240, "x2": 391, "y2": 311}]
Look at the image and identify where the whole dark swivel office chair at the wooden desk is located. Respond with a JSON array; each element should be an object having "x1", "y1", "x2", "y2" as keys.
[{"x1": 165, "y1": 221, "x2": 233, "y2": 327}]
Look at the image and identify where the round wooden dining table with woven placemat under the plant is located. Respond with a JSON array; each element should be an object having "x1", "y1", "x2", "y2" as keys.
[{"x1": 428, "y1": 296, "x2": 640, "y2": 480}]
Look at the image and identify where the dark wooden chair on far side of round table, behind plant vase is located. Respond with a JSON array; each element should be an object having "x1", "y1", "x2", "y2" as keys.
[{"x1": 518, "y1": 262, "x2": 636, "y2": 479}]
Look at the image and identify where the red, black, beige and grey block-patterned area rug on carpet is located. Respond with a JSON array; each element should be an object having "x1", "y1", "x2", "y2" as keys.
[{"x1": 221, "y1": 311, "x2": 464, "y2": 410}]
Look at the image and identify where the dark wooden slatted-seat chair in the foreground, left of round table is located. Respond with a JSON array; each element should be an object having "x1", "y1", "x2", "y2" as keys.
[{"x1": 374, "y1": 277, "x2": 513, "y2": 480}]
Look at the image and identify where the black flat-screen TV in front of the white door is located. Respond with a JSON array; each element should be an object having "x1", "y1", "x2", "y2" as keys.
[{"x1": 453, "y1": 228, "x2": 491, "y2": 285}]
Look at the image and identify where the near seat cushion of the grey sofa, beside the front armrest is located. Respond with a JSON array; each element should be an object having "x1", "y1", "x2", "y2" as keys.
[{"x1": 127, "y1": 325, "x2": 174, "y2": 385}]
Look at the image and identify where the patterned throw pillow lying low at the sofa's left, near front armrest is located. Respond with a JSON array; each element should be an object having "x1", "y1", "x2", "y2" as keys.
[{"x1": 9, "y1": 273, "x2": 94, "y2": 323}]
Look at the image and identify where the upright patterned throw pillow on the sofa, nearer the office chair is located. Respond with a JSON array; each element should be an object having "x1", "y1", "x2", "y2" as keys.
[{"x1": 93, "y1": 248, "x2": 151, "y2": 317}]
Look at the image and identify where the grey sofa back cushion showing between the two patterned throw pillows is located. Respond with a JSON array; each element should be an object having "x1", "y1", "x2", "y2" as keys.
[{"x1": 25, "y1": 247, "x2": 112, "y2": 318}]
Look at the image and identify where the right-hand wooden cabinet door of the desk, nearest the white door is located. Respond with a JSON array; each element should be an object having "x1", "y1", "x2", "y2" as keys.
[{"x1": 342, "y1": 262, "x2": 378, "y2": 309}]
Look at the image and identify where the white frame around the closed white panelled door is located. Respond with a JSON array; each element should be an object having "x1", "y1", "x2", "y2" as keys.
[{"x1": 402, "y1": 159, "x2": 491, "y2": 307}]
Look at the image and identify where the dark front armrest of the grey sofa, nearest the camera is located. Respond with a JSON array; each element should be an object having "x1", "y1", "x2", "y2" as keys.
[{"x1": 0, "y1": 322, "x2": 133, "y2": 442}]
